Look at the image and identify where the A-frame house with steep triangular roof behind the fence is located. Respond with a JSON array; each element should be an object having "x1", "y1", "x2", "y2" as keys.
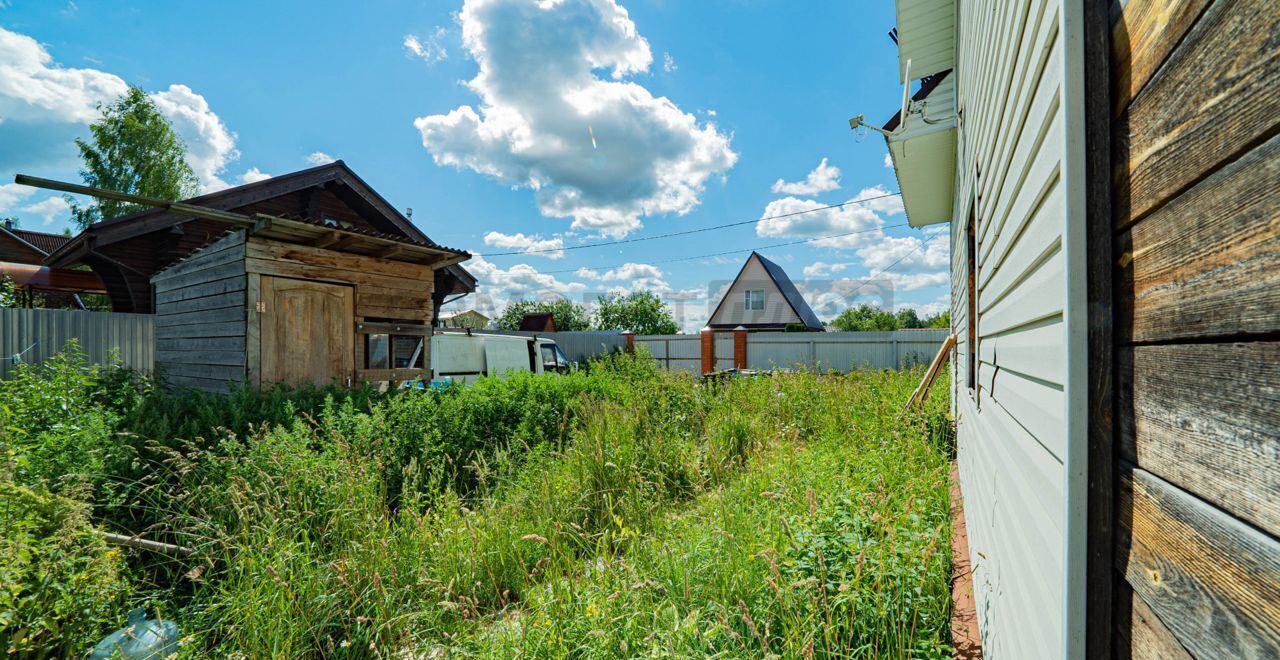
[{"x1": 707, "y1": 252, "x2": 823, "y2": 333}]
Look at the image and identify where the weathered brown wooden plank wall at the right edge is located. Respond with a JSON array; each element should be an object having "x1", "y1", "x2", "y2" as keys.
[{"x1": 1111, "y1": 0, "x2": 1280, "y2": 657}]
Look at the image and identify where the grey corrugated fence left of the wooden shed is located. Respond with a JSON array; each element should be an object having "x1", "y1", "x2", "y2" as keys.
[{"x1": 0, "y1": 308, "x2": 155, "y2": 379}]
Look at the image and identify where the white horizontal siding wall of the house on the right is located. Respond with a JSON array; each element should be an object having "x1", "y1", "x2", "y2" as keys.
[{"x1": 951, "y1": 0, "x2": 1068, "y2": 659}]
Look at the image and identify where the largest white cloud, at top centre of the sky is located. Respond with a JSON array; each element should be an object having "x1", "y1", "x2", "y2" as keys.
[{"x1": 413, "y1": 0, "x2": 737, "y2": 237}]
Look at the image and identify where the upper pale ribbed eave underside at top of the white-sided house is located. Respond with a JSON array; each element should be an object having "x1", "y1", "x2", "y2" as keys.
[{"x1": 897, "y1": 0, "x2": 956, "y2": 83}]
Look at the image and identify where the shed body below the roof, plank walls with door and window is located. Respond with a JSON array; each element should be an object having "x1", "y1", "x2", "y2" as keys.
[{"x1": 151, "y1": 229, "x2": 463, "y2": 390}]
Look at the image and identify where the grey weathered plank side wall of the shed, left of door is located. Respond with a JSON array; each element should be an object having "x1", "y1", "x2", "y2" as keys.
[{"x1": 151, "y1": 232, "x2": 246, "y2": 391}]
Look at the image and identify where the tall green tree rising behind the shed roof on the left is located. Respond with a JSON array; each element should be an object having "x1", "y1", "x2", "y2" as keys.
[{"x1": 67, "y1": 87, "x2": 200, "y2": 229}]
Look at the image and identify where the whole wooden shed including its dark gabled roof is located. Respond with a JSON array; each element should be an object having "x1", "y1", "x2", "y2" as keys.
[{"x1": 36, "y1": 161, "x2": 475, "y2": 391}]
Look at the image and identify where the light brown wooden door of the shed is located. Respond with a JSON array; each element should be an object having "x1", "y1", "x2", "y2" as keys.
[{"x1": 259, "y1": 275, "x2": 356, "y2": 385}]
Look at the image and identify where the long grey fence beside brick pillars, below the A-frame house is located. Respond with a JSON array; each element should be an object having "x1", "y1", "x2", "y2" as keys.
[{"x1": 635, "y1": 329, "x2": 950, "y2": 372}]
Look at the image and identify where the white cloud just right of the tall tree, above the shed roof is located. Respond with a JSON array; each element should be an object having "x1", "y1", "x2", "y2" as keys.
[{"x1": 151, "y1": 84, "x2": 239, "y2": 192}]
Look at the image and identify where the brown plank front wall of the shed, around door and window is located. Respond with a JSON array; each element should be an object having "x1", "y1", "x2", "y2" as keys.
[{"x1": 244, "y1": 237, "x2": 435, "y2": 382}]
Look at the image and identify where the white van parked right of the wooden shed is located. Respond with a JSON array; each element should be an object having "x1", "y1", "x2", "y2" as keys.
[{"x1": 431, "y1": 331, "x2": 570, "y2": 384}]
